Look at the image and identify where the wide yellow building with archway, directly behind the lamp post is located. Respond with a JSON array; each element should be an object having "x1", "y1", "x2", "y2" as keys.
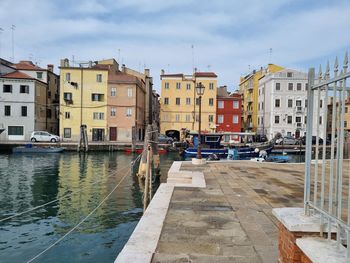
[{"x1": 160, "y1": 71, "x2": 217, "y2": 133}]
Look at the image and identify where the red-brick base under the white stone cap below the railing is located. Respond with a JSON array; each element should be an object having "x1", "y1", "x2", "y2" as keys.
[{"x1": 278, "y1": 223, "x2": 320, "y2": 263}]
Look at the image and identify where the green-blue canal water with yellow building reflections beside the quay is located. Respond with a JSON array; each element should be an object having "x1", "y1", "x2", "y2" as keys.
[{"x1": 0, "y1": 152, "x2": 180, "y2": 263}]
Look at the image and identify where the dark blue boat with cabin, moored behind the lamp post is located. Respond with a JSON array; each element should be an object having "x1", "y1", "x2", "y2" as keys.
[{"x1": 182, "y1": 133, "x2": 228, "y2": 159}]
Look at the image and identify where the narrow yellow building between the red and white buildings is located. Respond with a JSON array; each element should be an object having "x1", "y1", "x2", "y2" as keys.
[{"x1": 239, "y1": 64, "x2": 283, "y2": 132}]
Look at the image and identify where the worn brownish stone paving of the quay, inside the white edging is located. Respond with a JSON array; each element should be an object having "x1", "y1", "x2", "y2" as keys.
[{"x1": 152, "y1": 161, "x2": 304, "y2": 263}]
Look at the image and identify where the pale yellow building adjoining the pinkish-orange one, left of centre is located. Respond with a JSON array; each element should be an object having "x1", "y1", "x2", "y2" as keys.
[{"x1": 60, "y1": 59, "x2": 108, "y2": 141}]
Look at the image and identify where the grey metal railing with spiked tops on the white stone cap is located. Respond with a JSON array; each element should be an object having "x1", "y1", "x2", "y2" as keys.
[{"x1": 304, "y1": 53, "x2": 350, "y2": 257}]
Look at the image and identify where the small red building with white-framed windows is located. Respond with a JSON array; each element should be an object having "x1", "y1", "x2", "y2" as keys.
[{"x1": 216, "y1": 86, "x2": 242, "y2": 140}]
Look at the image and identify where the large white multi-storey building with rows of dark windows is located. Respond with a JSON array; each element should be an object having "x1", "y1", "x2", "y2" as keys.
[{"x1": 257, "y1": 69, "x2": 325, "y2": 139}]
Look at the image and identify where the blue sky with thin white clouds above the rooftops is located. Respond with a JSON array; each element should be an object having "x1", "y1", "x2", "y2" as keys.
[{"x1": 0, "y1": 0, "x2": 350, "y2": 90}]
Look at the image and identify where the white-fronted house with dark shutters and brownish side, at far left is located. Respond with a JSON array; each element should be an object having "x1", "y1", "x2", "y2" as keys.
[{"x1": 0, "y1": 60, "x2": 58, "y2": 141}]
